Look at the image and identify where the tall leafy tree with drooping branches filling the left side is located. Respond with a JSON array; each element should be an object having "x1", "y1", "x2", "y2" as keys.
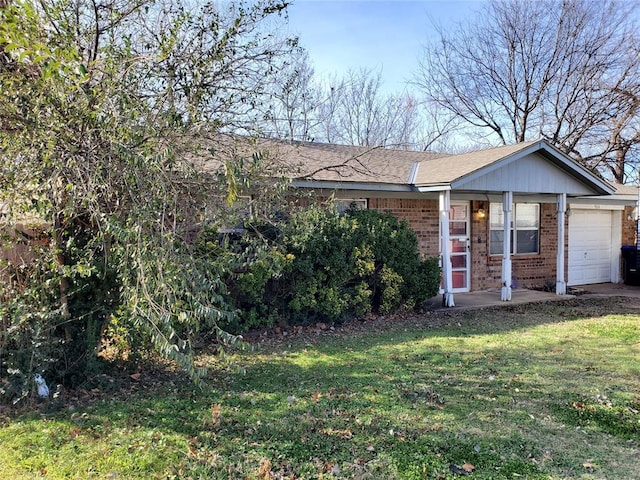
[{"x1": 0, "y1": 0, "x2": 295, "y2": 396}]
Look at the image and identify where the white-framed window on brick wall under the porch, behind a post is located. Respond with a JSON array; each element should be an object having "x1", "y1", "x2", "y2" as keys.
[{"x1": 489, "y1": 203, "x2": 540, "y2": 255}]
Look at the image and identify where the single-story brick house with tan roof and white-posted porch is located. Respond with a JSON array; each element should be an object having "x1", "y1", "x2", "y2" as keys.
[{"x1": 259, "y1": 140, "x2": 638, "y2": 306}]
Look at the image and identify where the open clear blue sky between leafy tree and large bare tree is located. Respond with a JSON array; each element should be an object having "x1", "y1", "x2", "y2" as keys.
[{"x1": 289, "y1": 0, "x2": 482, "y2": 93}]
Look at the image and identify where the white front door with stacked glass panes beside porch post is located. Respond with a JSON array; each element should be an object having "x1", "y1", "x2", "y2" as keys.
[{"x1": 449, "y1": 201, "x2": 471, "y2": 293}]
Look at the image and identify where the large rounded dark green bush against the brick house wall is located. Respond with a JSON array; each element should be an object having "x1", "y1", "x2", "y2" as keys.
[{"x1": 220, "y1": 205, "x2": 440, "y2": 331}]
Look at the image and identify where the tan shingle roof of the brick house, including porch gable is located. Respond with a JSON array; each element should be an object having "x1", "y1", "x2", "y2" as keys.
[{"x1": 206, "y1": 136, "x2": 613, "y2": 194}]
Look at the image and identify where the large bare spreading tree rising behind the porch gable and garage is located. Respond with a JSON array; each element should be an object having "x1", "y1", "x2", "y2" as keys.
[{"x1": 416, "y1": 0, "x2": 640, "y2": 182}]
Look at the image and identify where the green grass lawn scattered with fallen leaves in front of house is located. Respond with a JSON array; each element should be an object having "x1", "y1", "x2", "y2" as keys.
[{"x1": 0, "y1": 298, "x2": 640, "y2": 480}]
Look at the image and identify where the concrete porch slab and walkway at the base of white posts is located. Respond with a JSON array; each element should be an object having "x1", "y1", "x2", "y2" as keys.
[{"x1": 426, "y1": 283, "x2": 640, "y2": 311}]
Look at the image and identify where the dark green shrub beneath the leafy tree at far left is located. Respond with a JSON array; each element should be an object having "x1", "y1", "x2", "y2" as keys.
[{"x1": 0, "y1": 239, "x2": 118, "y2": 403}]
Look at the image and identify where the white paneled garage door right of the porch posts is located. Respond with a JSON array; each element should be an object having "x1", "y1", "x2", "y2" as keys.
[{"x1": 567, "y1": 209, "x2": 612, "y2": 285}]
